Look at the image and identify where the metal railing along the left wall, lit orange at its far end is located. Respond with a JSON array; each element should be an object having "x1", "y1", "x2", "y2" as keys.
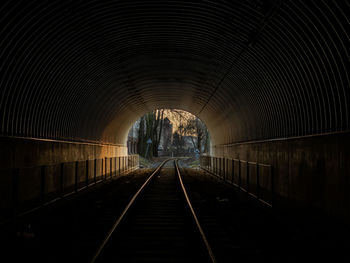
[{"x1": 0, "y1": 155, "x2": 139, "y2": 224}]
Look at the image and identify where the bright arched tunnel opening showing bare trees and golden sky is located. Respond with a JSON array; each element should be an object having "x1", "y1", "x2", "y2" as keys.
[{"x1": 127, "y1": 109, "x2": 210, "y2": 159}]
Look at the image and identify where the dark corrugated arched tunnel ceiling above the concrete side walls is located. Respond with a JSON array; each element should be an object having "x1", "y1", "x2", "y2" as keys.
[{"x1": 0, "y1": 0, "x2": 350, "y2": 144}]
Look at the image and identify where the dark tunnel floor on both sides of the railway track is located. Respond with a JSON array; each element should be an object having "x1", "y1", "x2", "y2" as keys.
[{"x1": 1, "y1": 168, "x2": 350, "y2": 263}]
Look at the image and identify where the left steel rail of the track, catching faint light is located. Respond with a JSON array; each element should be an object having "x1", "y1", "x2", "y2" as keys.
[{"x1": 90, "y1": 158, "x2": 172, "y2": 263}]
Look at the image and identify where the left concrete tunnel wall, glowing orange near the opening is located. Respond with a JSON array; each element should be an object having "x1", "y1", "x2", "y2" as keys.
[{"x1": 0, "y1": 137, "x2": 131, "y2": 224}]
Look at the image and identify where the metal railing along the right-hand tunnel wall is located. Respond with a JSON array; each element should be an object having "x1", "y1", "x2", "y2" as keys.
[{"x1": 200, "y1": 155, "x2": 274, "y2": 207}]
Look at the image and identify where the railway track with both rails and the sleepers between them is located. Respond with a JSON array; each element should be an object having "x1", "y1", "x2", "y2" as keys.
[{"x1": 90, "y1": 160, "x2": 216, "y2": 263}]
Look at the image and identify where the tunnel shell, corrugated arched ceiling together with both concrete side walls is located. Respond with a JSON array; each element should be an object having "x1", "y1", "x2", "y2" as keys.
[{"x1": 0, "y1": 0, "x2": 350, "y2": 262}]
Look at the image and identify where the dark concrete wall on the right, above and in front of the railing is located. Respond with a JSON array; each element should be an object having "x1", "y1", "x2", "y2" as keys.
[{"x1": 213, "y1": 132, "x2": 350, "y2": 222}]
